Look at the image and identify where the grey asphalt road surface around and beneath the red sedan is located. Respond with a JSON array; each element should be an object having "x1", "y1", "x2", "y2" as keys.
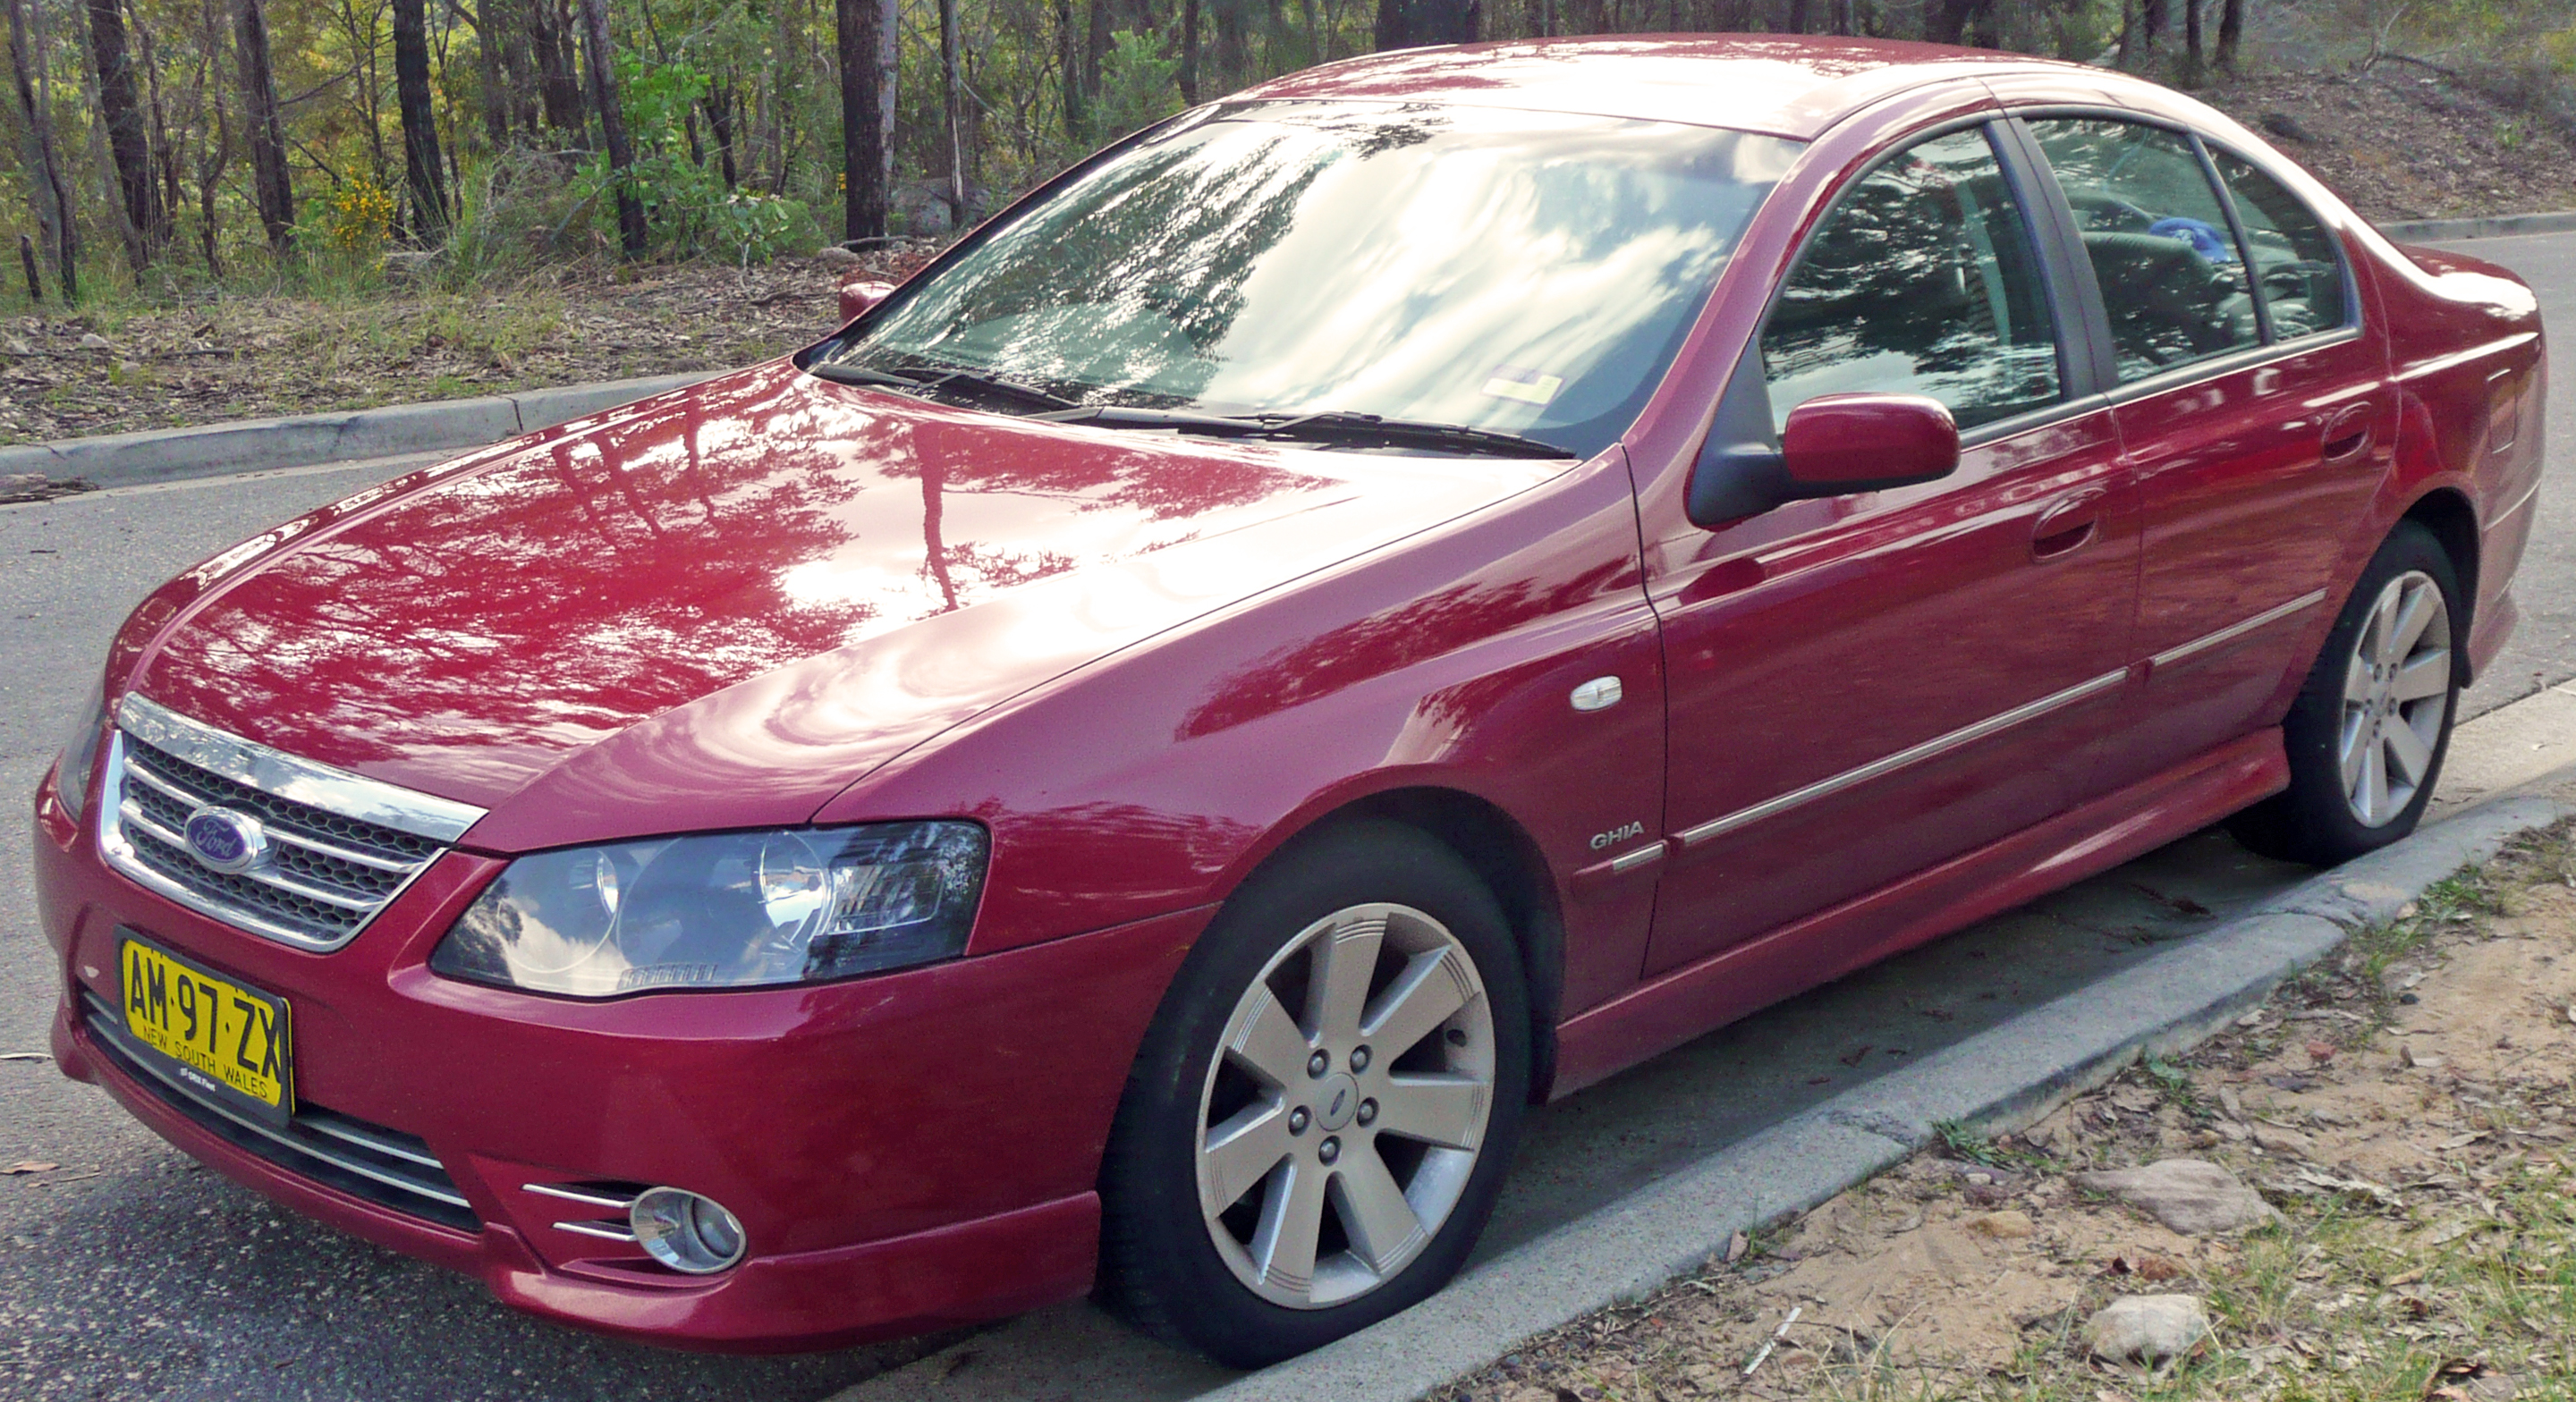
[{"x1": 0, "y1": 224, "x2": 2576, "y2": 1399}]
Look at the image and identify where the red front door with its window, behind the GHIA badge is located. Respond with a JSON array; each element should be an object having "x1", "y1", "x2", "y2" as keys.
[{"x1": 1646, "y1": 126, "x2": 2138, "y2": 975}]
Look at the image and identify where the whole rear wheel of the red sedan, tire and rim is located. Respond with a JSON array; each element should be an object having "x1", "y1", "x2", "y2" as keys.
[{"x1": 2231, "y1": 520, "x2": 2468, "y2": 866}]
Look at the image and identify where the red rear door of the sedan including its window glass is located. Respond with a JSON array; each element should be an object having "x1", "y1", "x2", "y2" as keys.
[{"x1": 2025, "y1": 114, "x2": 2395, "y2": 783}]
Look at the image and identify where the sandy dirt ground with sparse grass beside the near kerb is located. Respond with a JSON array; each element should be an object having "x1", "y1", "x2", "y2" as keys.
[{"x1": 1432, "y1": 827, "x2": 2576, "y2": 1402}]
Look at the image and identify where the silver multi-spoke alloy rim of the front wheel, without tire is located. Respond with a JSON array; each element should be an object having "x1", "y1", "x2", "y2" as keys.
[{"x1": 1198, "y1": 905, "x2": 1494, "y2": 1309}]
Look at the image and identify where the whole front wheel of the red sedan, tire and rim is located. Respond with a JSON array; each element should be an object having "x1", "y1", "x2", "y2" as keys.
[{"x1": 1103, "y1": 822, "x2": 1530, "y2": 1366}]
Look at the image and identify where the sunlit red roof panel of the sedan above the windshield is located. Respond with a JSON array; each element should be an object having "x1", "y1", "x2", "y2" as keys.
[{"x1": 1236, "y1": 33, "x2": 2120, "y2": 142}]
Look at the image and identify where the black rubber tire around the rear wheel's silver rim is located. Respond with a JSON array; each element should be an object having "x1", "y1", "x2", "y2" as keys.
[{"x1": 2228, "y1": 520, "x2": 2468, "y2": 866}]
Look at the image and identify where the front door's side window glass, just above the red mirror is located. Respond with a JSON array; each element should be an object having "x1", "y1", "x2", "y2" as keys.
[{"x1": 1762, "y1": 129, "x2": 2058, "y2": 427}]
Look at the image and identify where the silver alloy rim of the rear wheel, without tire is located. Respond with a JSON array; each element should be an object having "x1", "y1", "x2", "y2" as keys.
[{"x1": 2336, "y1": 570, "x2": 2453, "y2": 827}]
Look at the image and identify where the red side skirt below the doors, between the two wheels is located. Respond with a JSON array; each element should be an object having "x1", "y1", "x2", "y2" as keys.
[{"x1": 1548, "y1": 730, "x2": 2290, "y2": 1101}]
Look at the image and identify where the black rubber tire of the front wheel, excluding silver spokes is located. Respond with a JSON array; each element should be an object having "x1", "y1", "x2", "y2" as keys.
[{"x1": 1100, "y1": 820, "x2": 1530, "y2": 1369}]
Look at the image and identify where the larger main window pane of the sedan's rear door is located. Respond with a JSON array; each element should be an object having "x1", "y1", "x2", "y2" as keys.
[{"x1": 2029, "y1": 119, "x2": 2262, "y2": 382}]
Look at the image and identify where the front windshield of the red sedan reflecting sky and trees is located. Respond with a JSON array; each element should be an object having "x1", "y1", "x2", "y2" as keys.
[{"x1": 822, "y1": 103, "x2": 1798, "y2": 456}]
